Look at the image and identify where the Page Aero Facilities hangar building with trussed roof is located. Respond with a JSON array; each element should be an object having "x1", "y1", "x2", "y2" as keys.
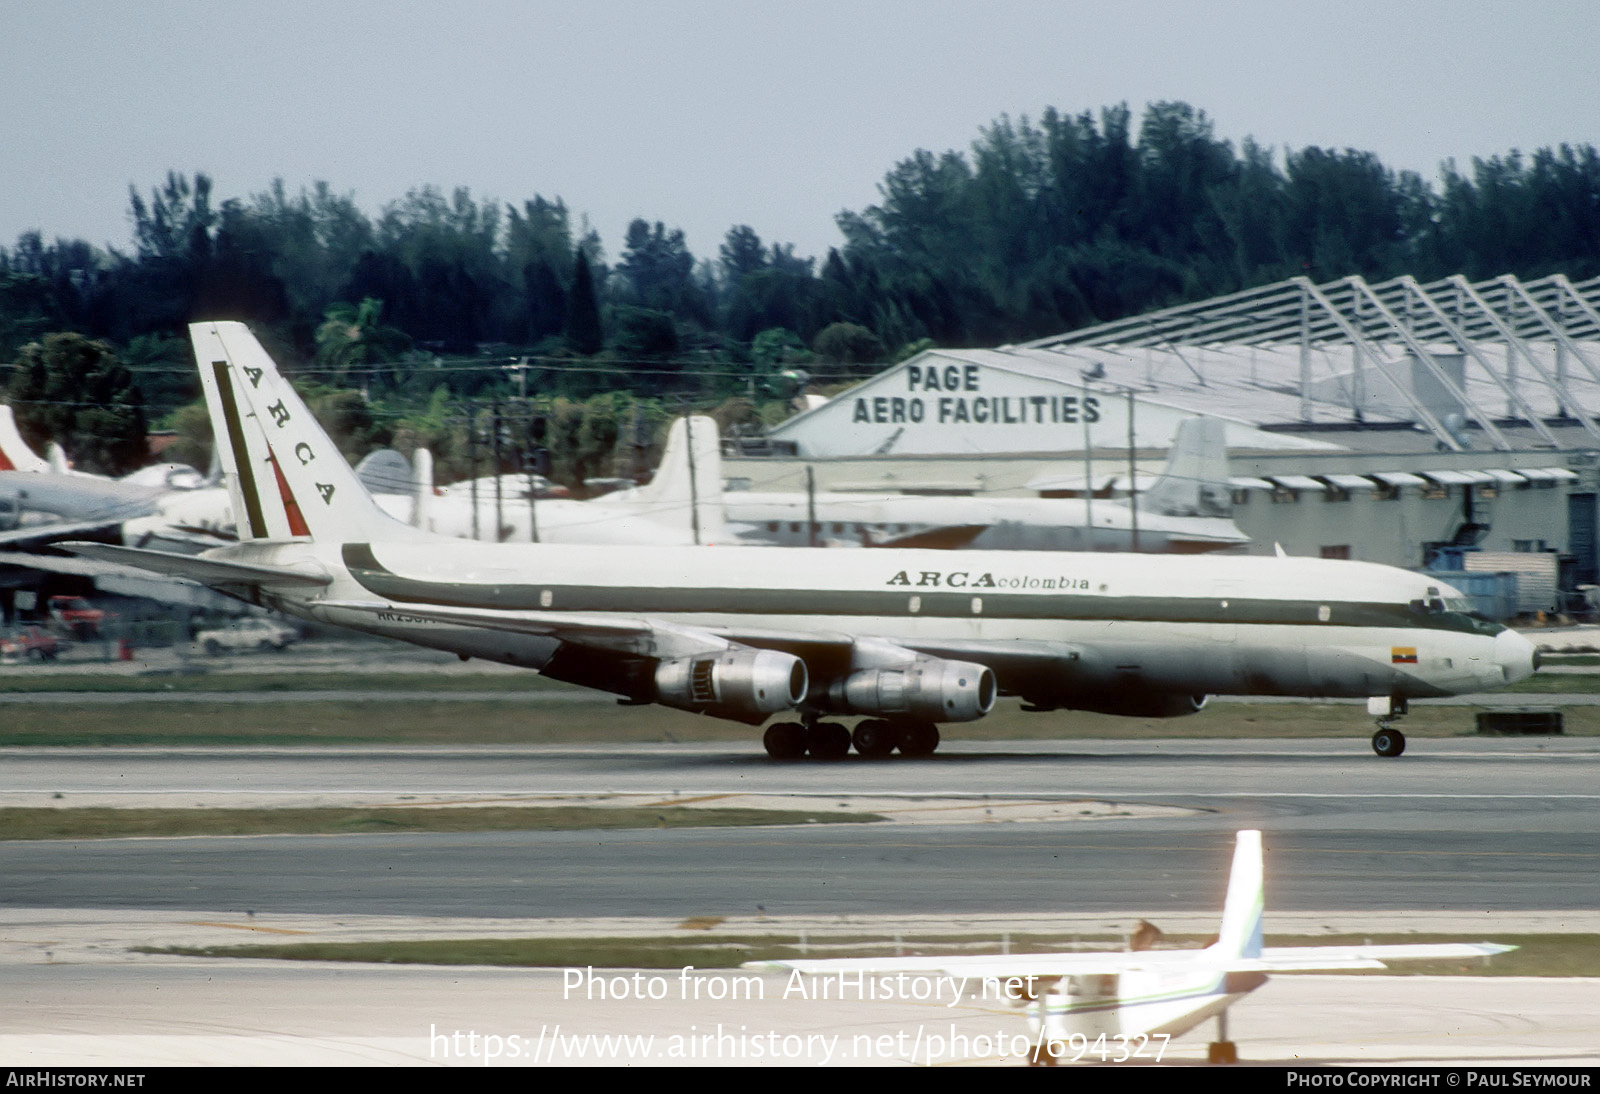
[{"x1": 726, "y1": 275, "x2": 1600, "y2": 606}]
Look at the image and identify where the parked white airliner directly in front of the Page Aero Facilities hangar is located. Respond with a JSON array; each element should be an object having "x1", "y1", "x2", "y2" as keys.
[{"x1": 725, "y1": 417, "x2": 1250, "y2": 553}]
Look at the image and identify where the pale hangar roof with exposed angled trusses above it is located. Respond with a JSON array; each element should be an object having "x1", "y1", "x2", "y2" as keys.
[{"x1": 994, "y1": 275, "x2": 1600, "y2": 451}]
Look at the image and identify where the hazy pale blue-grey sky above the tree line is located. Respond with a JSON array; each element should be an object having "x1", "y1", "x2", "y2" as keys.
[{"x1": 0, "y1": 0, "x2": 1600, "y2": 261}]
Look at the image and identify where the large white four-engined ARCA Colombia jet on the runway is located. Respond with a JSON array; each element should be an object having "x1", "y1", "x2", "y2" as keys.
[{"x1": 65, "y1": 323, "x2": 1536, "y2": 758}]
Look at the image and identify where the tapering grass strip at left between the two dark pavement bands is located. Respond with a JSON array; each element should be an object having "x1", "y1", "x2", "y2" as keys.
[{"x1": 0, "y1": 806, "x2": 883, "y2": 840}]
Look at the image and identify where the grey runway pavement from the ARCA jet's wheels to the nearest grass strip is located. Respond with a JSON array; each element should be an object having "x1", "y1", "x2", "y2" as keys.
[{"x1": 0, "y1": 739, "x2": 1600, "y2": 916}]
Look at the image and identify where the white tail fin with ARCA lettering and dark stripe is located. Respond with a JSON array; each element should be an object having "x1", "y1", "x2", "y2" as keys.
[{"x1": 189, "y1": 323, "x2": 406, "y2": 542}]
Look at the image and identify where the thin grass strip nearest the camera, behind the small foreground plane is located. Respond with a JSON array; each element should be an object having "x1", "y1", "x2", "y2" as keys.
[{"x1": 136, "y1": 931, "x2": 1600, "y2": 977}]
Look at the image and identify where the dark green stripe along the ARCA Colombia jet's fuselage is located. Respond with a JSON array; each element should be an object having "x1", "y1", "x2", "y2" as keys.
[{"x1": 344, "y1": 544, "x2": 1491, "y2": 633}]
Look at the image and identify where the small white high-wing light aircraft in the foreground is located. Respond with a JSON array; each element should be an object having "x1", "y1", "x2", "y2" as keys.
[{"x1": 744, "y1": 830, "x2": 1517, "y2": 1065}]
